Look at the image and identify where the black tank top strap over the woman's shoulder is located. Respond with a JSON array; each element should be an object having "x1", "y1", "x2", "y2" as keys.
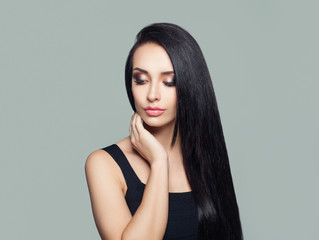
[{"x1": 101, "y1": 144, "x2": 143, "y2": 190}]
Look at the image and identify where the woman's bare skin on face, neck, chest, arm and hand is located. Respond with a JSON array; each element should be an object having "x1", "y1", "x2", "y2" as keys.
[{"x1": 85, "y1": 43, "x2": 191, "y2": 240}]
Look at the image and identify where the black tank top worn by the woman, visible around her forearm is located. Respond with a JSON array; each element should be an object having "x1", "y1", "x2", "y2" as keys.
[{"x1": 102, "y1": 144, "x2": 198, "y2": 240}]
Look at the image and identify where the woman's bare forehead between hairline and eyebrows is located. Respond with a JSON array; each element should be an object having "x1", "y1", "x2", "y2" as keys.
[{"x1": 133, "y1": 43, "x2": 174, "y2": 72}]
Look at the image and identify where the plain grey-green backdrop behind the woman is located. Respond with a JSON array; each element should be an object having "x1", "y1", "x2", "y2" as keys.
[{"x1": 0, "y1": 0, "x2": 319, "y2": 240}]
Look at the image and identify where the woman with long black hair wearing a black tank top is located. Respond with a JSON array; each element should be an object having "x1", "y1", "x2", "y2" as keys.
[{"x1": 85, "y1": 23, "x2": 242, "y2": 240}]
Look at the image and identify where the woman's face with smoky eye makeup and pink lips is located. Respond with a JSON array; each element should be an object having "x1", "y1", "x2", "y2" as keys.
[{"x1": 132, "y1": 43, "x2": 177, "y2": 127}]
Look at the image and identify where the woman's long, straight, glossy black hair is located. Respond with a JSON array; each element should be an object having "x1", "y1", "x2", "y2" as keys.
[{"x1": 125, "y1": 23, "x2": 243, "y2": 240}]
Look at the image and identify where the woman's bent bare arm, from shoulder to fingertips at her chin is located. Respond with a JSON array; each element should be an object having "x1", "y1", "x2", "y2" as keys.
[{"x1": 85, "y1": 113, "x2": 168, "y2": 240}]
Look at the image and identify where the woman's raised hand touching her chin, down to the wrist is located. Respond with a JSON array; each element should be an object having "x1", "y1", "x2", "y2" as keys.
[{"x1": 130, "y1": 112, "x2": 168, "y2": 166}]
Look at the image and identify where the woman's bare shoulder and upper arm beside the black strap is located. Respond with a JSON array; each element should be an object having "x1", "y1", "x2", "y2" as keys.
[{"x1": 85, "y1": 142, "x2": 132, "y2": 239}]
